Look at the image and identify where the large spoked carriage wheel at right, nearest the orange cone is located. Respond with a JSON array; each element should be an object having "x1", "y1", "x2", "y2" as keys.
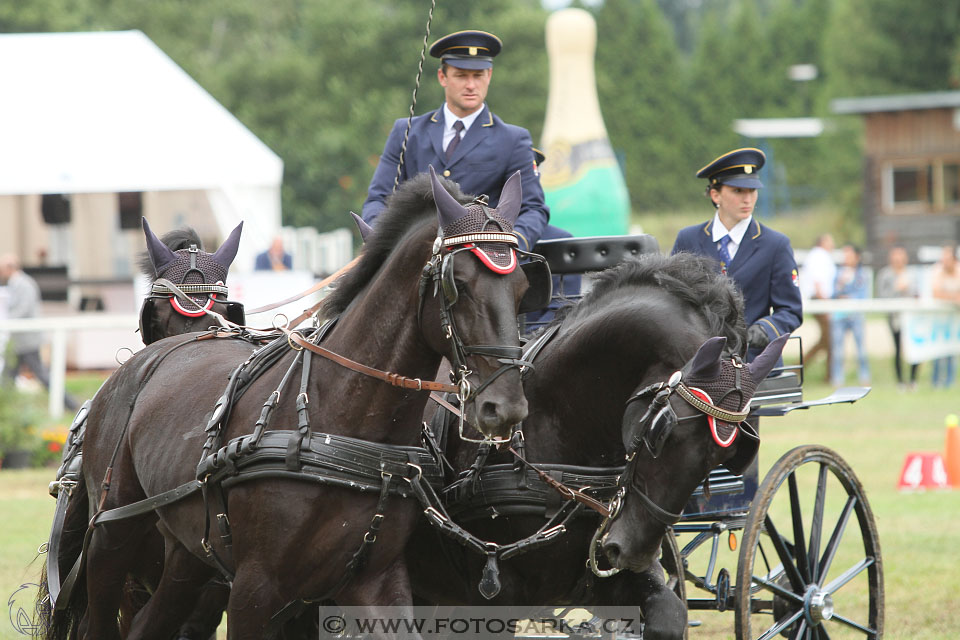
[{"x1": 735, "y1": 445, "x2": 883, "y2": 640}]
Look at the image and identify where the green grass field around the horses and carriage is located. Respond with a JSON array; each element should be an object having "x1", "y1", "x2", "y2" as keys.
[{"x1": 0, "y1": 359, "x2": 960, "y2": 640}]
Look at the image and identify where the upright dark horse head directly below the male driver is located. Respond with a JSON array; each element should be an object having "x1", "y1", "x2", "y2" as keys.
[{"x1": 420, "y1": 167, "x2": 549, "y2": 438}]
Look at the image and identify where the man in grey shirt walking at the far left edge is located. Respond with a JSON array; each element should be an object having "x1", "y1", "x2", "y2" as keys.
[{"x1": 0, "y1": 255, "x2": 79, "y2": 411}]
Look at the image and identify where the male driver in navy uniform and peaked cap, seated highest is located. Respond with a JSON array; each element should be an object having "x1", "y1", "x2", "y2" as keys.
[{"x1": 363, "y1": 31, "x2": 570, "y2": 251}]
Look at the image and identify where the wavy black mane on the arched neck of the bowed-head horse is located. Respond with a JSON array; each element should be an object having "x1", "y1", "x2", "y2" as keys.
[{"x1": 556, "y1": 253, "x2": 747, "y2": 354}]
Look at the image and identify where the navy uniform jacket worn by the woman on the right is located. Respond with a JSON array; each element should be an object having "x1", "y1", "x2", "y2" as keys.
[{"x1": 671, "y1": 218, "x2": 803, "y2": 355}]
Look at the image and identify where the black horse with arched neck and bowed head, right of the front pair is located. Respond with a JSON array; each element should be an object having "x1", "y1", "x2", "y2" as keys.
[{"x1": 407, "y1": 254, "x2": 782, "y2": 639}]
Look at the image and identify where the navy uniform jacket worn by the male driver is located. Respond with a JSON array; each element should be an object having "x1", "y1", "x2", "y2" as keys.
[{"x1": 362, "y1": 105, "x2": 550, "y2": 251}]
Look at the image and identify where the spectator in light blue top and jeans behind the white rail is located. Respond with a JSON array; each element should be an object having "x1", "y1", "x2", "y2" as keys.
[{"x1": 830, "y1": 244, "x2": 870, "y2": 387}]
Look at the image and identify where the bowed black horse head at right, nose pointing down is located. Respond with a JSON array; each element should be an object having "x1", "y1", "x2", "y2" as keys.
[{"x1": 591, "y1": 335, "x2": 789, "y2": 571}]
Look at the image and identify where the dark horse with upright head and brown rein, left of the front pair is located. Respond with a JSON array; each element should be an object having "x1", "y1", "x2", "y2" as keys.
[{"x1": 48, "y1": 174, "x2": 540, "y2": 639}]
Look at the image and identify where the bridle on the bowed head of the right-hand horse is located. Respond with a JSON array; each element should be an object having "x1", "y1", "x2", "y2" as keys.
[{"x1": 588, "y1": 356, "x2": 760, "y2": 578}]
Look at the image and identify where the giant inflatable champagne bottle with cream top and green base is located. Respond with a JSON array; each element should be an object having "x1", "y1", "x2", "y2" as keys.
[{"x1": 540, "y1": 9, "x2": 630, "y2": 236}]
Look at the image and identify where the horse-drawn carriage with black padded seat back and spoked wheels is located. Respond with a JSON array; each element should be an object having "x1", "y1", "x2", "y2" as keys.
[{"x1": 520, "y1": 235, "x2": 884, "y2": 640}]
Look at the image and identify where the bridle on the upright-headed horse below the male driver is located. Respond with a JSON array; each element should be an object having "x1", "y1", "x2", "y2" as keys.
[{"x1": 417, "y1": 231, "x2": 546, "y2": 443}]
